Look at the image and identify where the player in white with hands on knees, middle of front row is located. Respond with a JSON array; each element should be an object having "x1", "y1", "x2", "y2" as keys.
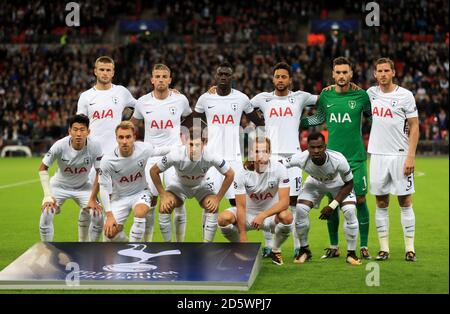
[{"x1": 150, "y1": 129, "x2": 234, "y2": 242}]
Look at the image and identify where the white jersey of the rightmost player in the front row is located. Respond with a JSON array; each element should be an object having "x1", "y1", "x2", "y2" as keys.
[{"x1": 282, "y1": 149, "x2": 353, "y2": 188}]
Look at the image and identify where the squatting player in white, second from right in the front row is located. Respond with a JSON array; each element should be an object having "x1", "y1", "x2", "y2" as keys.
[{"x1": 219, "y1": 137, "x2": 293, "y2": 265}]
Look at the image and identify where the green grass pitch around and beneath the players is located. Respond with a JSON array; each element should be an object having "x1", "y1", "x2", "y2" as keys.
[{"x1": 0, "y1": 157, "x2": 449, "y2": 294}]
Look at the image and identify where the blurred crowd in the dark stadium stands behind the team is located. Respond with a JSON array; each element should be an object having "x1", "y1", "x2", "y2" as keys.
[{"x1": 0, "y1": 0, "x2": 449, "y2": 153}]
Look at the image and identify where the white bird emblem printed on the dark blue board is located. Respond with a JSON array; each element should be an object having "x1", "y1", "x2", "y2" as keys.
[{"x1": 103, "y1": 244, "x2": 181, "y2": 273}]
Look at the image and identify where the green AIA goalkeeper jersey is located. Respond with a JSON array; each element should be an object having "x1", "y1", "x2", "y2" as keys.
[{"x1": 301, "y1": 87, "x2": 371, "y2": 163}]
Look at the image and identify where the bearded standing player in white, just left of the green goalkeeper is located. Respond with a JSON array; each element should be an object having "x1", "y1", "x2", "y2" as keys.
[{"x1": 250, "y1": 62, "x2": 319, "y2": 257}]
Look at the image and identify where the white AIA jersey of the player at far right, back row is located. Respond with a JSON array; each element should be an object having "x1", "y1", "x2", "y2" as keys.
[{"x1": 367, "y1": 86, "x2": 418, "y2": 156}]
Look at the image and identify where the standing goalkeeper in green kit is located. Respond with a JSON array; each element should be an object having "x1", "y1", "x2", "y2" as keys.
[{"x1": 301, "y1": 57, "x2": 371, "y2": 259}]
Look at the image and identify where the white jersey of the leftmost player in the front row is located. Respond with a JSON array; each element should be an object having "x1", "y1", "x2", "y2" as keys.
[{"x1": 42, "y1": 136, "x2": 103, "y2": 190}]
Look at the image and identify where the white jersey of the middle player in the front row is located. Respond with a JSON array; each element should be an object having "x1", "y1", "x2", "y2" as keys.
[{"x1": 156, "y1": 144, "x2": 230, "y2": 186}]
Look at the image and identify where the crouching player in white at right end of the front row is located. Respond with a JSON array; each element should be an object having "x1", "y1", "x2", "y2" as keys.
[{"x1": 282, "y1": 132, "x2": 361, "y2": 265}]
